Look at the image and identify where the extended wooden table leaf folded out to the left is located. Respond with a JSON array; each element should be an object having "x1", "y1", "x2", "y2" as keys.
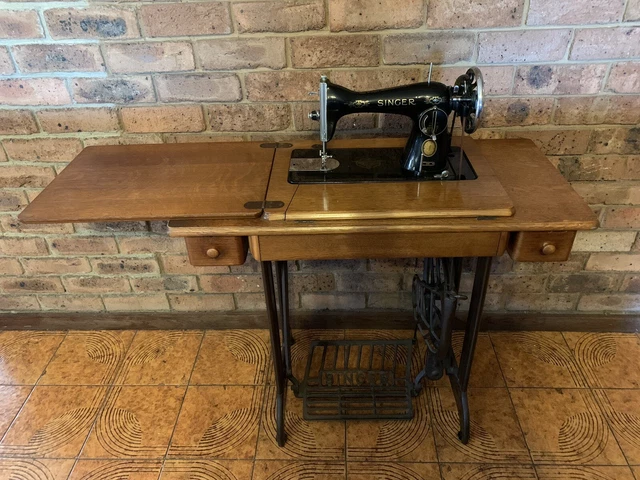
[{"x1": 19, "y1": 142, "x2": 274, "y2": 223}]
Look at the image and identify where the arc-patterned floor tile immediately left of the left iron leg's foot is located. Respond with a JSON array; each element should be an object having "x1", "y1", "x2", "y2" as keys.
[{"x1": 169, "y1": 386, "x2": 264, "y2": 459}]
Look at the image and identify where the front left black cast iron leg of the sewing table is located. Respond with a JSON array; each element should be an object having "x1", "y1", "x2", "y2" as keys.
[{"x1": 261, "y1": 262, "x2": 286, "y2": 447}]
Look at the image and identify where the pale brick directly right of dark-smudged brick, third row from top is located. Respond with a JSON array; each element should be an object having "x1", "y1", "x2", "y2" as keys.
[{"x1": 104, "y1": 42, "x2": 195, "y2": 73}]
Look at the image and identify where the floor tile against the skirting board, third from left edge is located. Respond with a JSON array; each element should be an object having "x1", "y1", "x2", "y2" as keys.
[{"x1": 116, "y1": 330, "x2": 203, "y2": 385}]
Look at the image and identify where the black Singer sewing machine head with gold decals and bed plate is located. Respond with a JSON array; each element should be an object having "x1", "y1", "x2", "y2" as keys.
[{"x1": 294, "y1": 67, "x2": 483, "y2": 183}]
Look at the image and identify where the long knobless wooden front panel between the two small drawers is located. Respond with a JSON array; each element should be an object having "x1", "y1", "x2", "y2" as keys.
[{"x1": 251, "y1": 232, "x2": 507, "y2": 260}]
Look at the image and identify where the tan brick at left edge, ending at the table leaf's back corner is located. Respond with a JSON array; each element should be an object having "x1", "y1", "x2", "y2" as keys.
[{"x1": 2, "y1": 138, "x2": 82, "y2": 162}]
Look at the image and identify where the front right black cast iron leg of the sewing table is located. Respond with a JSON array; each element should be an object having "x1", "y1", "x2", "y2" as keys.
[{"x1": 449, "y1": 257, "x2": 492, "y2": 444}]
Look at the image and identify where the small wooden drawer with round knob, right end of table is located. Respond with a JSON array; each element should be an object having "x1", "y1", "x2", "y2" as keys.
[{"x1": 508, "y1": 231, "x2": 576, "y2": 262}]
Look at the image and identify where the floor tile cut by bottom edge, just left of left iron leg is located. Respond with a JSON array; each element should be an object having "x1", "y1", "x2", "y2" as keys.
[{"x1": 160, "y1": 459, "x2": 253, "y2": 480}]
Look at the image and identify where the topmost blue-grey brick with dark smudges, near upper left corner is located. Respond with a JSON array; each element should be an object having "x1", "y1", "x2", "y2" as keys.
[{"x1": 44, "y1": 7, "x2": 140, "y2": 40}]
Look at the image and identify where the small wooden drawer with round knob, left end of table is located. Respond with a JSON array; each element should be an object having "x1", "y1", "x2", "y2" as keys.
[{"x1": 185, "y1": 237, "x2": 248, "y2": 267}]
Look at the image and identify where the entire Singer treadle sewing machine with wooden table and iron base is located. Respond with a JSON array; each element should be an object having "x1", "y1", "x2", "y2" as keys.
[{"x1": 20, "y1": 68, "x2": 597, "y2": 455}]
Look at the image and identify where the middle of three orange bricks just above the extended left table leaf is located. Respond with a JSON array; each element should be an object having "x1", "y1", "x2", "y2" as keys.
[{"x1": 121, "y1": 105, "x2": 204, "y2": 133}]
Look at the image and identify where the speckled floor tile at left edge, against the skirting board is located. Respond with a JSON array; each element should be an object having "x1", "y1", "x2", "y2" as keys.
[{"x1": 0, "y1": 332, "x2": 65, "y2": 385}]
